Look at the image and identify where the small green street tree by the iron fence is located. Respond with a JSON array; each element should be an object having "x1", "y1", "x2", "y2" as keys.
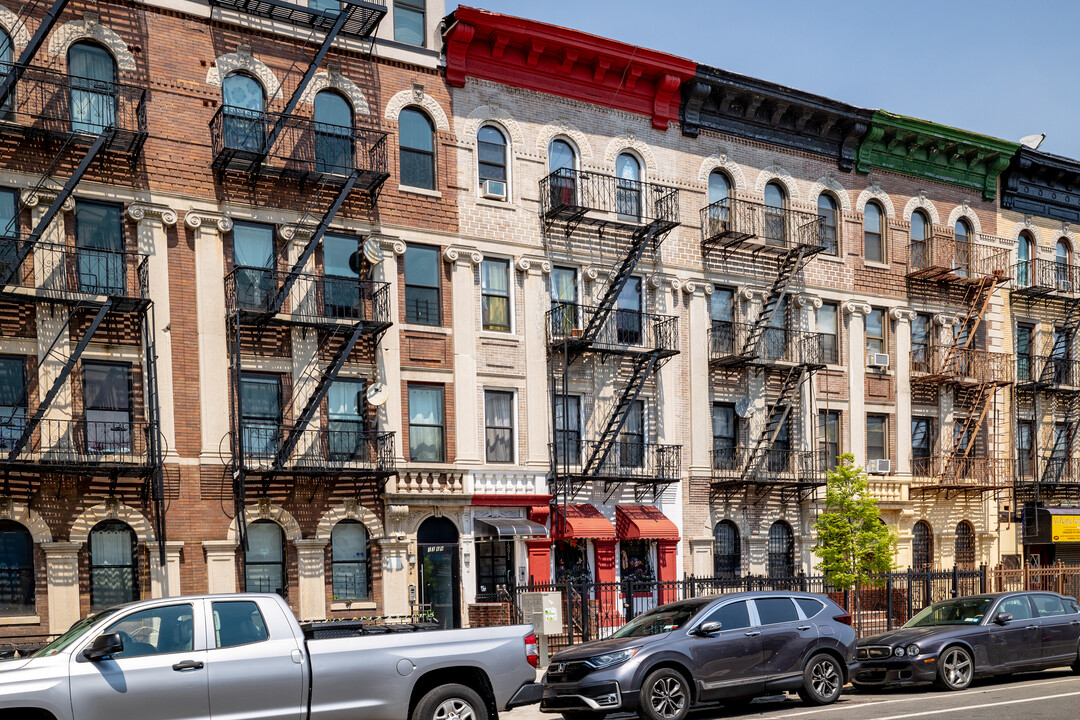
[{"x1": 813, "y1": 453, "x2": 896, "y2": 627}]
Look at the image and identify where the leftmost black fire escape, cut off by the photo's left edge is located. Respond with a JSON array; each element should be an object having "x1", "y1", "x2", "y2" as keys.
[{"x1": 0, "y1": 0, "x2": 166, "y2": 562}]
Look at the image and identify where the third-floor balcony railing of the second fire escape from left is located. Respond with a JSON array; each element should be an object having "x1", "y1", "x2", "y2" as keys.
[{"x1": 225, "y1": 266, "x2": 391, "y2": 328}]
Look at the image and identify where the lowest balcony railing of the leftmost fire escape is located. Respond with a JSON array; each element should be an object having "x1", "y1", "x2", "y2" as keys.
[{"x1": 0, "y1": 410, "x2": 158, "y2": 473}]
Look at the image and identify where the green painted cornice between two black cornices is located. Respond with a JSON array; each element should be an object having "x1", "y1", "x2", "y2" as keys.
[{"x1": 855, "y1": 110, "x2": 1020, "y2": 200}]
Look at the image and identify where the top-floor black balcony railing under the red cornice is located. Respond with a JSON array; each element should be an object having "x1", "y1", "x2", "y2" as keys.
[{"x1": 540, "y1": 168, "x2": 679, "y2": 234}]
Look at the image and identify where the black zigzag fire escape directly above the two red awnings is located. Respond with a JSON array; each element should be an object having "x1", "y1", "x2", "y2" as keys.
[{"x1": 540, "y1": 169, "x2": 681, "y2": 517}]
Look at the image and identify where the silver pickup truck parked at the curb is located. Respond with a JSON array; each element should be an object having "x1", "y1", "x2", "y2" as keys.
[{"x1": 0, "y1": 595, "x2": 541, "y2": 720}]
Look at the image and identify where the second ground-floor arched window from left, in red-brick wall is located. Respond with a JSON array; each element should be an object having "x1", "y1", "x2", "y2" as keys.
[{"x1": 90, "y1": 520, "x2": 138, "y2": 610}]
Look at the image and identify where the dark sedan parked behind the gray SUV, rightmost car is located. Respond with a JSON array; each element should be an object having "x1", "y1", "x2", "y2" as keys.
[{"x1": 852, "y1": 593, "x2": 1080, "y2": 690}]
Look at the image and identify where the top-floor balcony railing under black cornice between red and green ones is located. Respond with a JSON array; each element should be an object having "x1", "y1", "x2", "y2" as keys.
[{"x1": 701, "y1": 198, "x2": 835, "y2": 253}]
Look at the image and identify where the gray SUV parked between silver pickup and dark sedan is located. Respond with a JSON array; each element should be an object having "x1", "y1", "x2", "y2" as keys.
[{"x1": 540, "y1": 593, "x2": 858, "y2": 720}]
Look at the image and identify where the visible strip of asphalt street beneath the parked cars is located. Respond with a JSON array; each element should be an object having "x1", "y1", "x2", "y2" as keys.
[{"x1": 509, "y1": 668, "x2": 1080, "y2": 720}]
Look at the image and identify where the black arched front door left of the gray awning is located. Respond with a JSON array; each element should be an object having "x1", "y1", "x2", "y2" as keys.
[{"x1": 416, "y1": 517, "x2": 461, "y2": 628}]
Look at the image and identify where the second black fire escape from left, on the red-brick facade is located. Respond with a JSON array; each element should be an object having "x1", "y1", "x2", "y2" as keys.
[{"x1": 211, "y1": 0, "x2": 395, "y2": 546}]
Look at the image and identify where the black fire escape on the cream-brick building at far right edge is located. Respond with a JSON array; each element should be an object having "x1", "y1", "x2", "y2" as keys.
[{"x1": 1012, "y1": 258, "x2": 1080, "y2": 510}]
